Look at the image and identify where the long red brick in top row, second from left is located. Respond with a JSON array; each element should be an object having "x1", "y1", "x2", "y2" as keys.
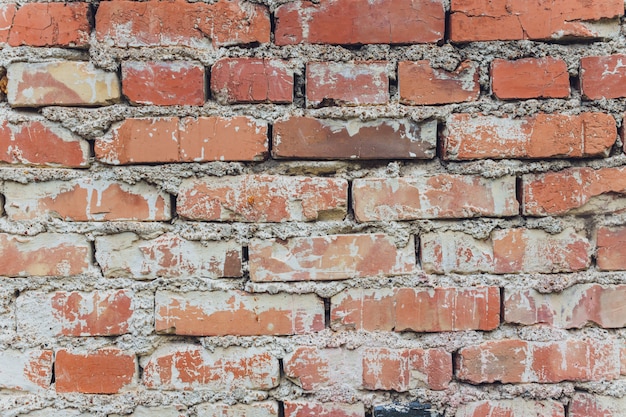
[{"x1": 96, "y1": 0, "x2": 270, "y2": 48}]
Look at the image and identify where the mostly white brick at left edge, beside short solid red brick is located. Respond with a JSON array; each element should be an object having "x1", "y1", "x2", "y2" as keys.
[{"x1": 0, "y1": 349, "x2": 53, "y2": 392}]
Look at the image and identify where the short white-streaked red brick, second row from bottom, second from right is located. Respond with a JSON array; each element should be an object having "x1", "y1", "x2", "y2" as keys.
[{"x1": 362, "y1": 348, "x2": 452, "y2": 392}]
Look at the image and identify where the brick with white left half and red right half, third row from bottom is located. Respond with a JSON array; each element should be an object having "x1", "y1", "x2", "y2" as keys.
[{"x1": 16, "y1": 290, "x2": 139, "y2": 338}]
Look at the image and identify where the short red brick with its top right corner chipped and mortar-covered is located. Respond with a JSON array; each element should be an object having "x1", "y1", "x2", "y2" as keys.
[{"x1": 398, "y1": 60, "x2": 480, "y2": 106}]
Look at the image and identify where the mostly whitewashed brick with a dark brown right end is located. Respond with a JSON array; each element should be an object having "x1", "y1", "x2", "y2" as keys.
[{"x1": 96, "y1": 233, "x2": 242, "y2": 279}]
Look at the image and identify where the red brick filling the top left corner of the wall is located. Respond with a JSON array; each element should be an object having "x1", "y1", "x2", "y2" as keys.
[{"x1": 5, "y1": 3, "x2": 91, "y2": 48}]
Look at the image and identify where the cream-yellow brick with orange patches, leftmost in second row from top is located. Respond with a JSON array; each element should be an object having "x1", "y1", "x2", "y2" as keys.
[{"x1": 7, "y1": 61, "x2": 120, "y2": 107}]
